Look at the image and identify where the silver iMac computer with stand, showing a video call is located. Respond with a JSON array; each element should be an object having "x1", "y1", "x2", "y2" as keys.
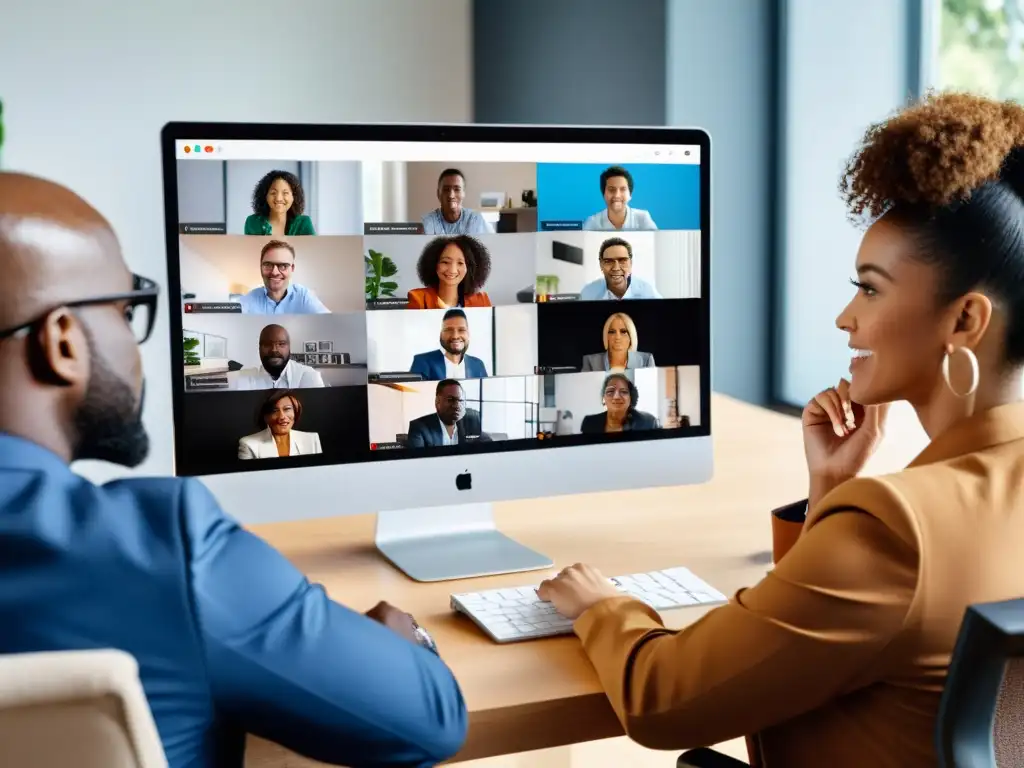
[{"x1": 162, "y1": 123, "x2": 713, "y2": 581}]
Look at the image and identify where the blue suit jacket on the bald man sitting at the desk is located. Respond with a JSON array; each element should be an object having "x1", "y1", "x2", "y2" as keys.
[{"x1": 0, "y1": 434, "x2": 467, "y2": 768}]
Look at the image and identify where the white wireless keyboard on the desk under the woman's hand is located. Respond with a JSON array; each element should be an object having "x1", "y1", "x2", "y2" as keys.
[{"x1": 452, "y1": 567, "x2": 728, "y2": 643}]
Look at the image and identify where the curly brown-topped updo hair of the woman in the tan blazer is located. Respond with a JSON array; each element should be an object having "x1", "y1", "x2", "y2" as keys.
[{"x1": 840, "y1": 93, "x2": 1024, "y2": 366}]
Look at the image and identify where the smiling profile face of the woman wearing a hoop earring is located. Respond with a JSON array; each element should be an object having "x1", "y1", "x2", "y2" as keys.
[{"x1": 836, "y1": 217, "x2": 955, "y2": 406}]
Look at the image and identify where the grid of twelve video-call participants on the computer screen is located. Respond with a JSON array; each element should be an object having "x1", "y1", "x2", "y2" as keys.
[{"x1": 172, "y1": 154, "x2": 707, "y2": 474}]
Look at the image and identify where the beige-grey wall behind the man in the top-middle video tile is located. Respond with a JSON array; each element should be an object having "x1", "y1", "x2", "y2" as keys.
[{"x1": 404, "y1": 158, "x2": 537, "y2": 221}]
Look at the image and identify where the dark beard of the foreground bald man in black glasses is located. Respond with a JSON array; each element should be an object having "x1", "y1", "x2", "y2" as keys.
[{"x1": 74, "y1": 331, "x2": 150, "y2": 468}]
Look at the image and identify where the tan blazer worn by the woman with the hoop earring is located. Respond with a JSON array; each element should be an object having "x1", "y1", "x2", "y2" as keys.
[{"x1": 575, "y1": 404, "x2": 1024, "y2": 768}]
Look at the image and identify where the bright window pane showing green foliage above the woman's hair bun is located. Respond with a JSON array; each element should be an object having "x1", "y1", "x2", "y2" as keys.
[{"x1": 934, "y1": 0, "x2": 1024, "y2": 101}]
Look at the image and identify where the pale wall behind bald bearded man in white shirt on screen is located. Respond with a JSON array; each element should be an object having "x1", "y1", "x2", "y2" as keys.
[{"x1": 182, "y1": 313, "x2": 367, "y2": 368}]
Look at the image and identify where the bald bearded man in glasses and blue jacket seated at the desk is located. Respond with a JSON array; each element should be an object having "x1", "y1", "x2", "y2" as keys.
[{"x1": 0, "y1": 173, "x2": 467, "y2": 768}]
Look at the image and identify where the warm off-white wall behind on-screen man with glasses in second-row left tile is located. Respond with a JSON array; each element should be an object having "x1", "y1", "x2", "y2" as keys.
[{"x1": 178, "y1": 234, "x2": 367, "y2": 312}]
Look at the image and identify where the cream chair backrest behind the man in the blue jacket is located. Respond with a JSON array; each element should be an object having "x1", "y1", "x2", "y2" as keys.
[{"x1": 0, "y1": 649, "x2": 167, "y2": 768}]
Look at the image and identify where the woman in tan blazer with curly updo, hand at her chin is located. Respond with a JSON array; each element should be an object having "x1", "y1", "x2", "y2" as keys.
[{"x1": 539, "y1": 94, "x2": 1024, "y2": 768}]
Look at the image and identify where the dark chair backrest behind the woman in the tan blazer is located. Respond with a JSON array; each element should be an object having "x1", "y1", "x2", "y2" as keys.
[{"x1": 936, "y1": 598, "x2": 1024, "y2": 768}]
